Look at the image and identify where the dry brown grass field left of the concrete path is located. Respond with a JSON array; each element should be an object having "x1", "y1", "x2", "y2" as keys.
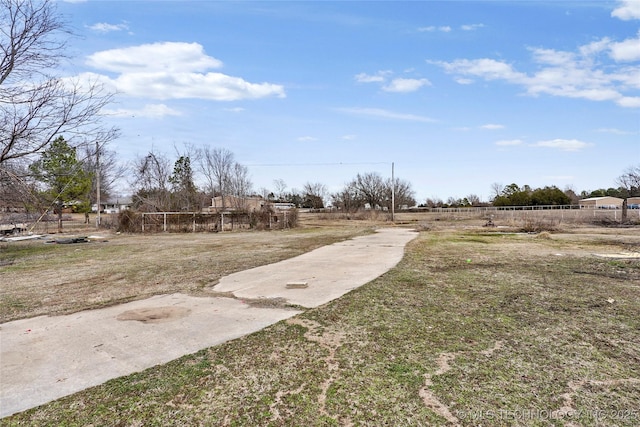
[{"x1": 0, "y1": 219, "x2": 371, "y2": 322}]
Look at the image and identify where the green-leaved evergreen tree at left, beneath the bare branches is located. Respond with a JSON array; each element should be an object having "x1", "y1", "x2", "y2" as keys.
[{"x1": 30, "y1": 136, "x2": 91, "y2": 231}]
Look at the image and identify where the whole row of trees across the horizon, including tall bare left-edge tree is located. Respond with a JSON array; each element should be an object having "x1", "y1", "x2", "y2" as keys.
[{"x1": 0, "y1": 0, "x2": 640, "y2": 229}]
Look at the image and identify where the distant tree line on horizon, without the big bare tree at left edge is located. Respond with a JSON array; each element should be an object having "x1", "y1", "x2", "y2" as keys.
[{"x1": 16, "y1": 137, "x2": 640, "y2": 217}]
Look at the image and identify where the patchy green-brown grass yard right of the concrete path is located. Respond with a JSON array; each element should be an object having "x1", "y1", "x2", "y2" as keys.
[{"x1": 0, "y1": 222, "x2": 640, "y2": 426}]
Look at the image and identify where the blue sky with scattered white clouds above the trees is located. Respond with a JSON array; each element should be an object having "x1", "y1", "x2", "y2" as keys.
[{"x1": 58, "y1": 0, "x2": 640, "y2": 202}]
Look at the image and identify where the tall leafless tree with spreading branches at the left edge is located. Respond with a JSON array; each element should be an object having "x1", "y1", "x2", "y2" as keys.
[{"x1": 0, "y1": 0, "x2": 112, "y2": 168}]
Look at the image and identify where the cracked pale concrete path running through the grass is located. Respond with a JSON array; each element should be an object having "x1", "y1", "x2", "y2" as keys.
[{"x1": 0, "y1": 228, "x2": 417, "y2": 417}]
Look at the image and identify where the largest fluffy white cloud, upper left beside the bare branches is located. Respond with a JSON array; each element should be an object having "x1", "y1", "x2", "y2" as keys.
[{"x1": 86, "y1": 42, "x2": 285, "y2": 101}]
